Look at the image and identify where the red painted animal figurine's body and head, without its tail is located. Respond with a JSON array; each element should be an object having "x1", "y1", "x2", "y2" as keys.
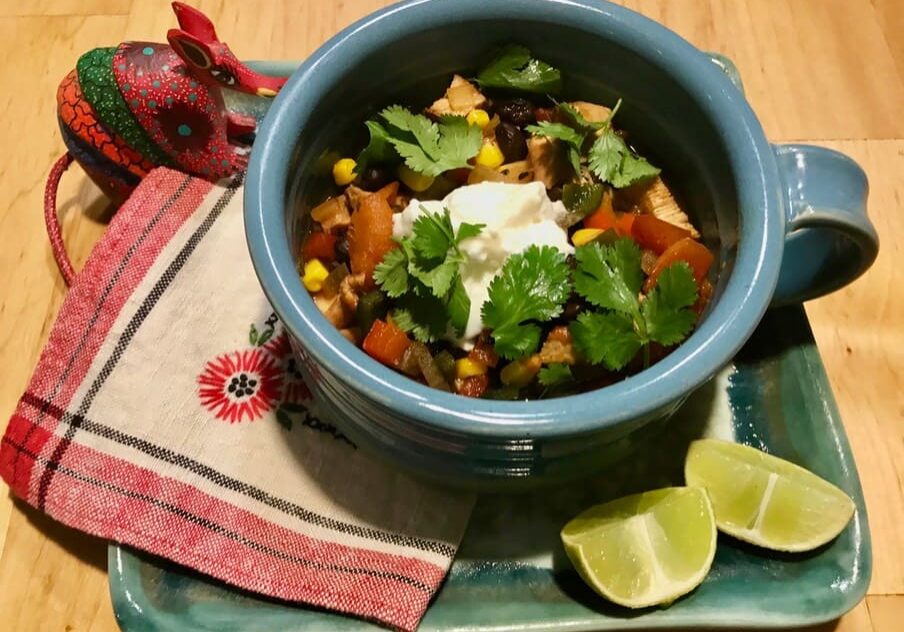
[{"x1": 57, "y1": 2, "x2": 286, "y2": 200}]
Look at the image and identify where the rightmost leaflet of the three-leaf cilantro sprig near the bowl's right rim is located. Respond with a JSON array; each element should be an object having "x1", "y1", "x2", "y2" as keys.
[{"x1": 640, "y1": 261, "x2": 697, "y2": 347}]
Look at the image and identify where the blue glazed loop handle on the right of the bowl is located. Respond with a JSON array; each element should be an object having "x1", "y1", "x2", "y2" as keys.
[{"x1": 772, "y1": 144, "x2": 879, "y2": 306}]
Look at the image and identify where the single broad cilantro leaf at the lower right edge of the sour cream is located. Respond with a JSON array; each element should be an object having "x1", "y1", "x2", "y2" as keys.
[{"x1": 481, "y1": 246, "x2": 571, "y2": 360}]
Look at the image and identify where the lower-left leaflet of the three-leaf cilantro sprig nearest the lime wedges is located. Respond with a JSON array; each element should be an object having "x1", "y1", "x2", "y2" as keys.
[{"x1": 569, "y1": 312, "x2": 644, "y2": 371}]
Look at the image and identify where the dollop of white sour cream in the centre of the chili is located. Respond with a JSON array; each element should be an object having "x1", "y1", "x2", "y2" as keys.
[{"x1": 392, "y1": 182, "x2": 574, "y2": 349}]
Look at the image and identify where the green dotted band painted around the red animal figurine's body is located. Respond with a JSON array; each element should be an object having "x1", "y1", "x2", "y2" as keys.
[{"x1": 76, "y1": 48, "x2": 173, "y2": 166}]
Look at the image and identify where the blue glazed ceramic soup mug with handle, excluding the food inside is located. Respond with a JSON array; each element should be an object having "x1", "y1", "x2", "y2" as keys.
[{"x1": 245, "y1": 0, "x2": 878, "y2": 485}]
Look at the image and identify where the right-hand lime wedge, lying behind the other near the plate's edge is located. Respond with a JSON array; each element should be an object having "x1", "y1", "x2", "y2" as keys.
[{"x1": 684, "y1": 439, "x2": 854, "y2": 552}]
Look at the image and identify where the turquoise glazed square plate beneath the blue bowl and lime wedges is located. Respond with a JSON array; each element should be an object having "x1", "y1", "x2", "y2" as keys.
[{"x1": 109, "y1": 307, "x2": 871, "y2": 632}]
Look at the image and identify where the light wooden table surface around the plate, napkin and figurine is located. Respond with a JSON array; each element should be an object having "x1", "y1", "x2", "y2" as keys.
[{"x1": 0, "y1": 0, "x2": 904, "y2": 632}]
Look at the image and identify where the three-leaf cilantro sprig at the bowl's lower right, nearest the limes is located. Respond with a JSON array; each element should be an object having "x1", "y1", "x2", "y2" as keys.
[{"x1": 570, "y1": 239, "x2": 697, "y2": 371}]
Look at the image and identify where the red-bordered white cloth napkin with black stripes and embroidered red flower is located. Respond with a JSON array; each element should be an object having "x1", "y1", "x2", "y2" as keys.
[{"x1": 0, "y1": 169, "x2": 473, "y2": 630}]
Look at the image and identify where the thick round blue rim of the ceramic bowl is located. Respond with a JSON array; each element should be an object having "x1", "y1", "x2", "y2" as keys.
[{"x1": 244, "y1": 0, "x2": 785, "y2": 439}]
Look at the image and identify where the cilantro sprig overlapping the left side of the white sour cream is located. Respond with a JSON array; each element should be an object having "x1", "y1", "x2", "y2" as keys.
[{"x1": 374, "y1": 206, "x2": 483, "y2": 342}]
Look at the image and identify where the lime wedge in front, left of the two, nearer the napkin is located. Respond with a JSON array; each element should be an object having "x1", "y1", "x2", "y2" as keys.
[{"x1": 561, "y1": 487, "x2": 716, "y2": 608}]
